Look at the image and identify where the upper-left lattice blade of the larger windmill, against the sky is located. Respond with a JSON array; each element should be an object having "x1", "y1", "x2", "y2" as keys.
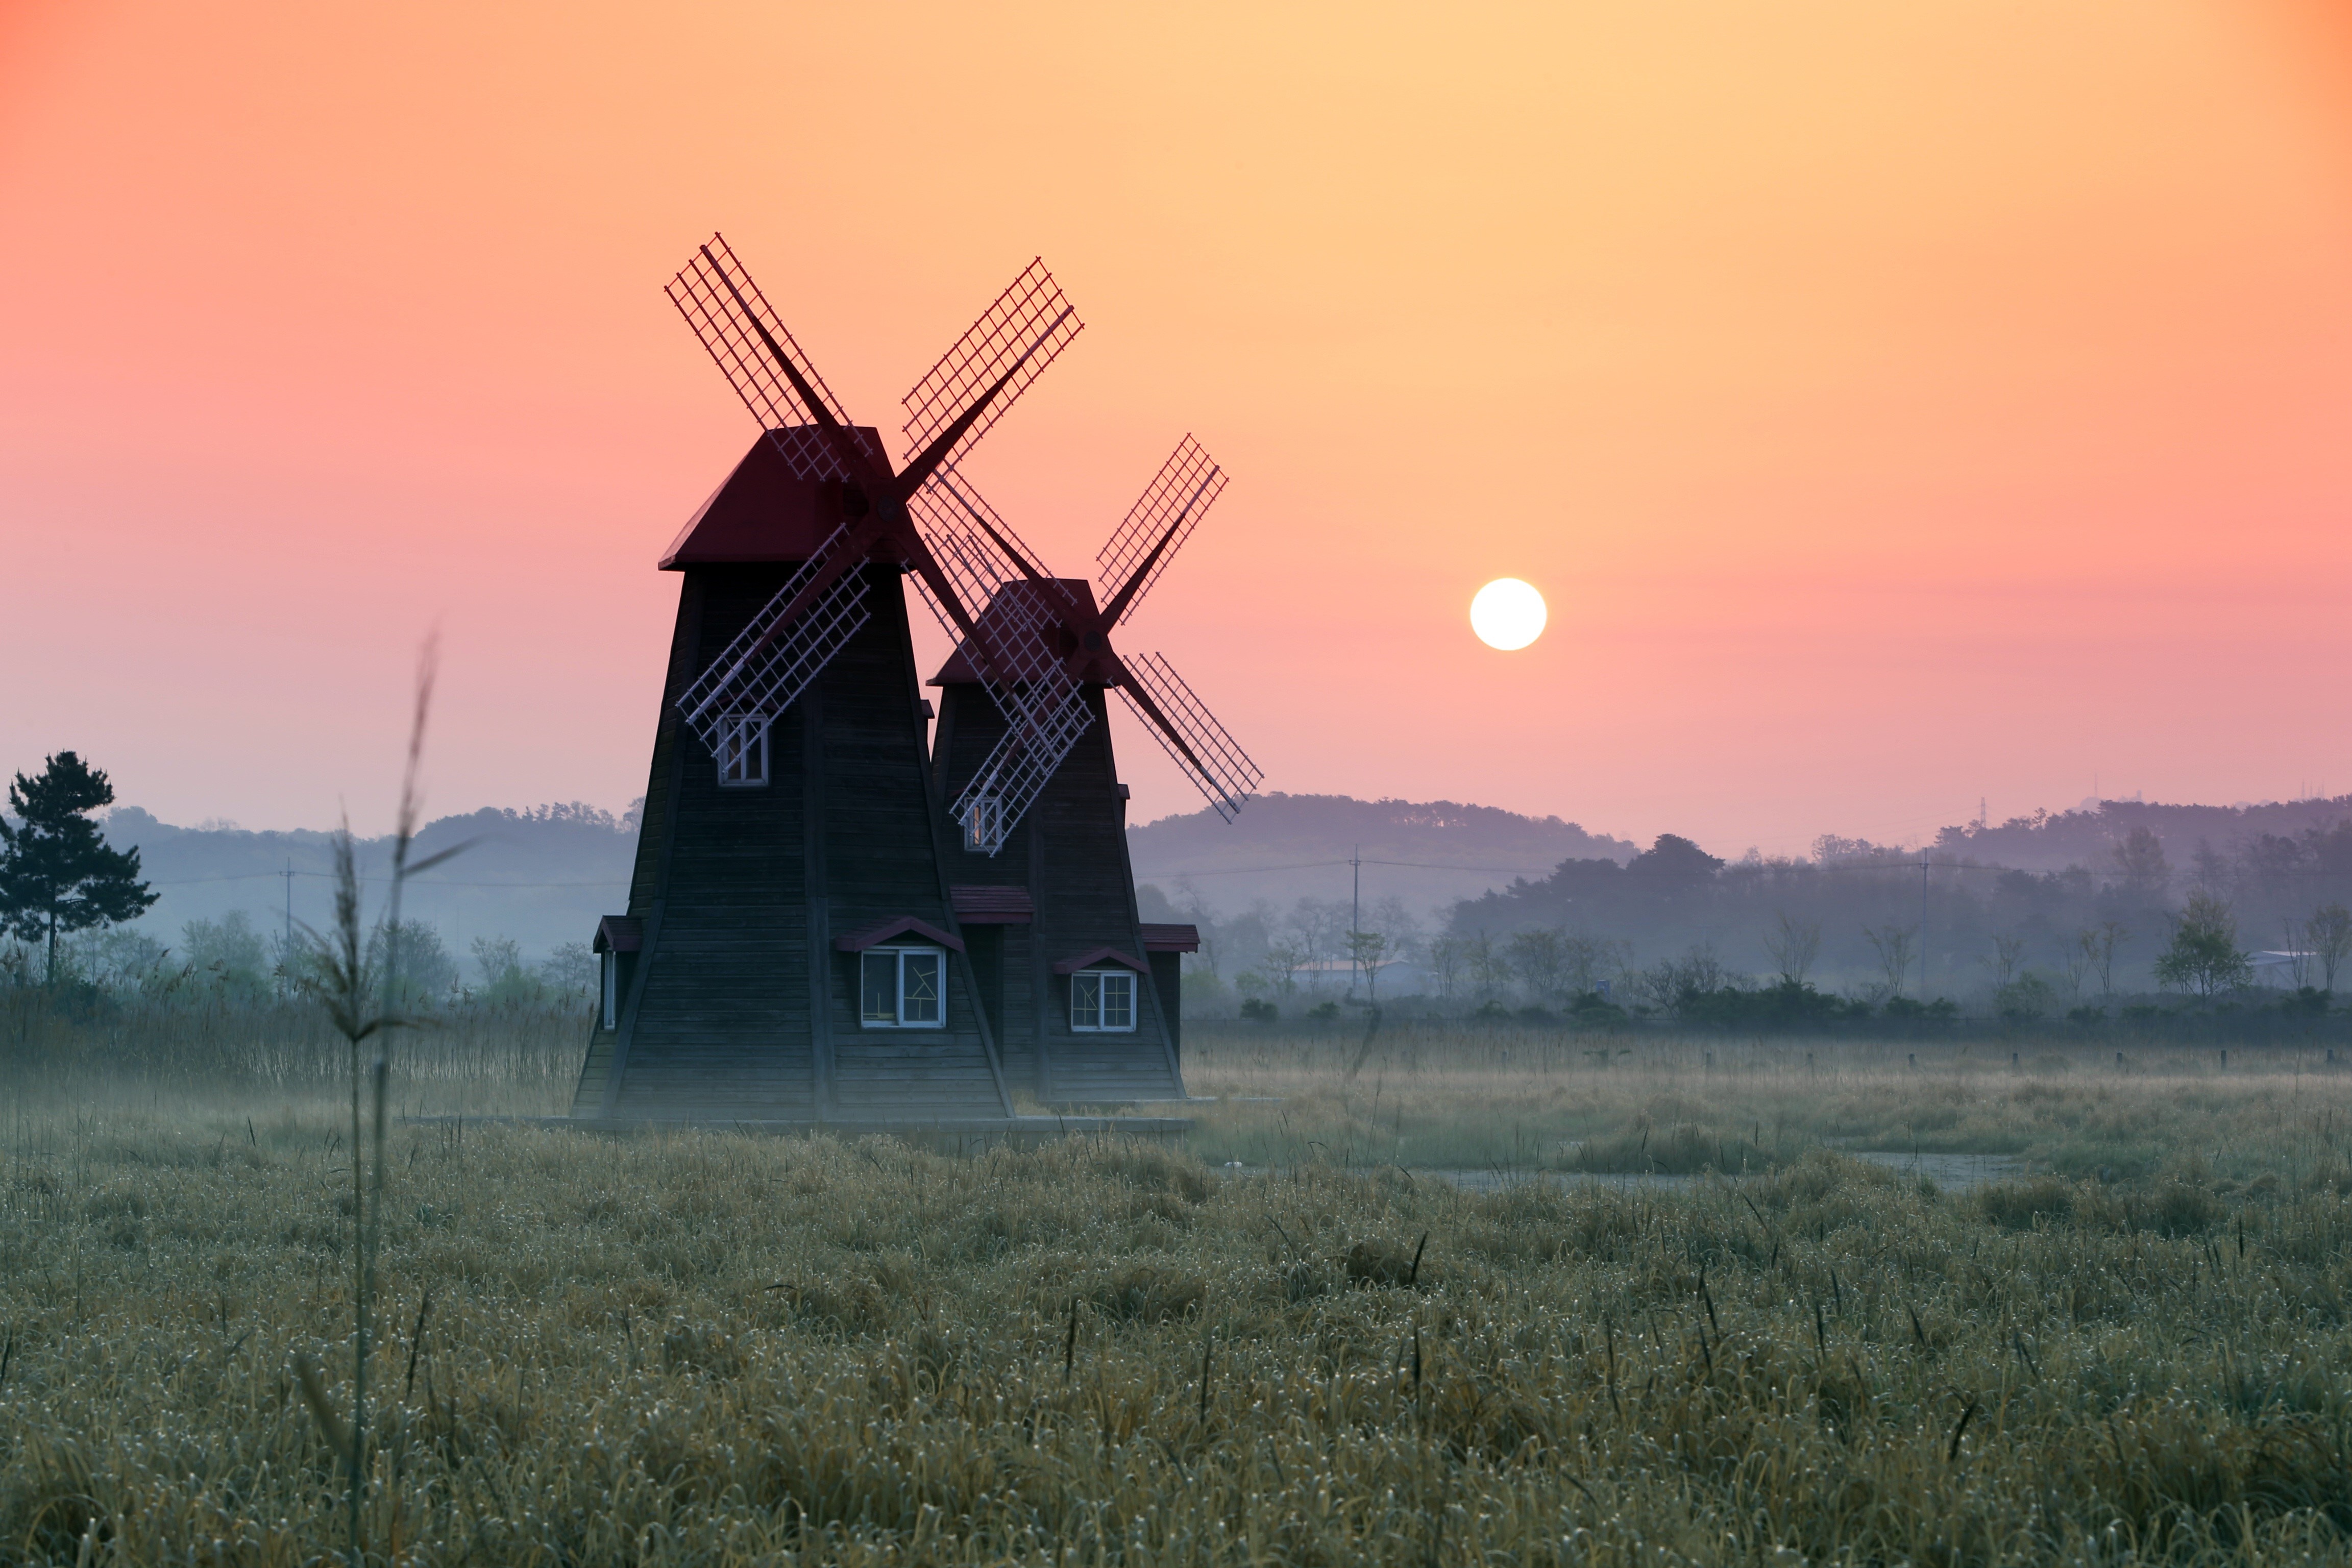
[{"x1": 666, "y1": 235, "x2": 882, "y2": 480}]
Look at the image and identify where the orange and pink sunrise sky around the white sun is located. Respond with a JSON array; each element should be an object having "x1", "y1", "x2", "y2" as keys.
[{"x1": 0, "y1": 0, "x2": 2352, "y2": 853}]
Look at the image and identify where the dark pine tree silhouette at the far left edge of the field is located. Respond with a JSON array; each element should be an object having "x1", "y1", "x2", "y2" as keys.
[{"x1": 0, "y1": 752, "x2": 158, "y2": 983}]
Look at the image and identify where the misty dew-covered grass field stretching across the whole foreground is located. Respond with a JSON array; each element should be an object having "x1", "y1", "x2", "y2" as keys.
[{"x1": 0, "y1": 1025, "x2": 2352, "y2": 1563}]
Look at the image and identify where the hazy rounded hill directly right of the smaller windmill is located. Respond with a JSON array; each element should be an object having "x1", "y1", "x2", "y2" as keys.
[{"x1": 1126, "y1": 795, "x2": 1637, "y2": 912}]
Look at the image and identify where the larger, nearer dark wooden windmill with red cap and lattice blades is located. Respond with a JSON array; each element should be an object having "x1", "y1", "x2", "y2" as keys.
[{"x1": 574, "y1": 235, "x2": 1082, "y2": 1121}]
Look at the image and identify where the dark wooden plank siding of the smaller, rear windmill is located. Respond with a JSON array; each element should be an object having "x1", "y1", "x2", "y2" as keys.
[{"x1": 932, "y1": 682, "x2": 1183, "y2": 1105}]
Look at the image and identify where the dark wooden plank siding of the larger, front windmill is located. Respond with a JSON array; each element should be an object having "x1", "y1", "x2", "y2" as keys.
[{"x1": 574, "y1": 564, "x2": 1009, "y2": 1121}]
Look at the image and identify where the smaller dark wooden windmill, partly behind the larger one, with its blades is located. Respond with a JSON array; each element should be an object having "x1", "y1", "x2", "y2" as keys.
[{"x1": 927, "y1": 437, "x2": 1263, "y2": 1102}]
